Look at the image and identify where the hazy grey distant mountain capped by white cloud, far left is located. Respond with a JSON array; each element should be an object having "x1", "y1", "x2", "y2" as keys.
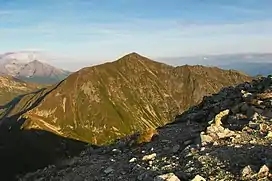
[{"x1": 0, "y1": 51, "x2": 71, "y2": 84}]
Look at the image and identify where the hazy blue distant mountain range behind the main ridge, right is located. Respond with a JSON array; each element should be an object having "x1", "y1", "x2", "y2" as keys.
[{"x1": 159, "y1": 53, "x2": 272, "y2": 76}]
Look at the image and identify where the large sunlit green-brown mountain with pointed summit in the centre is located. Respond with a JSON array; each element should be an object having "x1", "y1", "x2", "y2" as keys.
[{"x1": 2, "y1": 53, "x2": 251, "y2": 145}]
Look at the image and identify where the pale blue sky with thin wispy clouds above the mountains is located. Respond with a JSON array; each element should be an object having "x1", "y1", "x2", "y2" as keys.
[{"x1": 0, "y1": 0, "x2": 272, "y2": 70}]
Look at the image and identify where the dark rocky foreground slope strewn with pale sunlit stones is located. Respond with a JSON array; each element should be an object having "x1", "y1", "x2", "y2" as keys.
[{"x1": 19, "y1": 77, "x2": 272, "y2": 181}]
